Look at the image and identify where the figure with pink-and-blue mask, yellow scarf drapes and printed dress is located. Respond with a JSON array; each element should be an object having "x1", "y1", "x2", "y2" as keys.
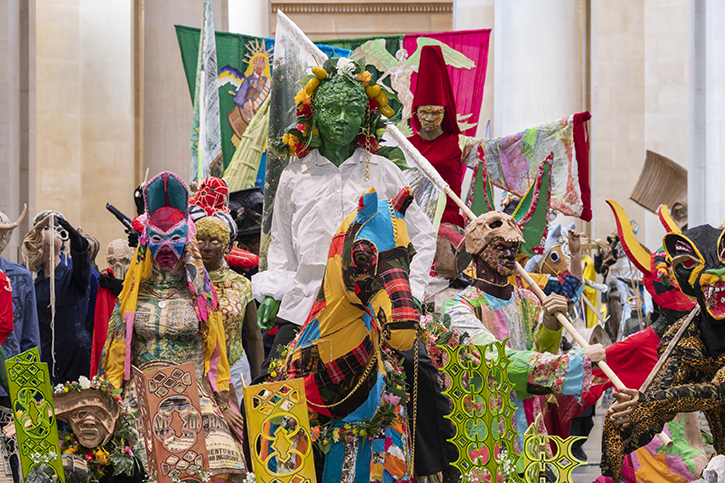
[{"x1": 101, "y1": 171, "x2": 247, "y2": 478}]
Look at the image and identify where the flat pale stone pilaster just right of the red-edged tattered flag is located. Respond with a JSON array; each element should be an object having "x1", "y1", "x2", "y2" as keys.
[{"x1": 590, "y1": 0, "x2": 644, "y2": 242}]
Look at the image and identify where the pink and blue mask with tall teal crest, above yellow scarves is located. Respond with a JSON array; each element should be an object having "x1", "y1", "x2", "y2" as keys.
[{"x1": 141, "y1": 171, "x2": 196, "y2": 270}]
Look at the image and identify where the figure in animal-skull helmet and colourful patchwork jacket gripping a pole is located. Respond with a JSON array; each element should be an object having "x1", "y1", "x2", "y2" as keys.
[{"x1": 443, "y1": 211, "x2": 604, "y2": 448}]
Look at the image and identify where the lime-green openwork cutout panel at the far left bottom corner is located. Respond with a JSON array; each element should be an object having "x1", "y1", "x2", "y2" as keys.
[{"x1": 5, "y1": 347, "x2": 65, "y2": 482}]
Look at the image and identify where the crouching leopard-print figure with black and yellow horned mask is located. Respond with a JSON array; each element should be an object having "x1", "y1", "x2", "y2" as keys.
[{"x1": 601, "y1": 225, "x2": 725, "y2": 481}]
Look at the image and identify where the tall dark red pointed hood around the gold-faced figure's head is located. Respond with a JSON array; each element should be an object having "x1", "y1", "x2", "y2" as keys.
[{"x1": 413, "y1": 45, "x2": 461, "y2": 134}]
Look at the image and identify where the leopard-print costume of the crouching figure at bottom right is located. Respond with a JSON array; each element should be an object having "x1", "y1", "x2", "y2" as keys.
[{"x1": 600, "y1": 316, "x2": 725, "y2": 482}]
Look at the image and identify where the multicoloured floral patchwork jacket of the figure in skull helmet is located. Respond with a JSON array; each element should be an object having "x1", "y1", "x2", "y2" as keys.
[{"x1": 443, "y1": 286, "x2": 591, "y2": 448}]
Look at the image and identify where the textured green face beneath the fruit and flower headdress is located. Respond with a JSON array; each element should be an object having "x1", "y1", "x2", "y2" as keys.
[{"x1": 312, "y1": 75, "x2": 368, "y2": 146}]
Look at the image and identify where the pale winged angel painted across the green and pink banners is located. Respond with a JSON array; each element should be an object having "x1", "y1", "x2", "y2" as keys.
[{"x1": 350, "y1": 37, "x2": 476, "y2": 121}]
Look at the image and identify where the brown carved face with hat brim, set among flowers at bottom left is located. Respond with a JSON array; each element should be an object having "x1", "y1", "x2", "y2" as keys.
[{"x1": 53, "y1": 389, "x2": 119, "y2": 448}]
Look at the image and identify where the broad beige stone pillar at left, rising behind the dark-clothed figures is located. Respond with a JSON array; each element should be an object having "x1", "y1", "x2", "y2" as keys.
[{"x1": 35, "y1": 0, "x2": 134, "y2": 268}]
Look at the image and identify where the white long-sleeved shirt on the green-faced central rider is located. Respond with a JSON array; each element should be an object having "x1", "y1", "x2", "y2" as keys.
[{"x1": 252, "y1": 148, "x2": 436, "y2": 325}]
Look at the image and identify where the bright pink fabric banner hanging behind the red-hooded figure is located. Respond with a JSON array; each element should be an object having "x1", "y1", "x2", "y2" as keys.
[{"x1": 403, "y1": 29, "x2": 491, "y2": 136}]
